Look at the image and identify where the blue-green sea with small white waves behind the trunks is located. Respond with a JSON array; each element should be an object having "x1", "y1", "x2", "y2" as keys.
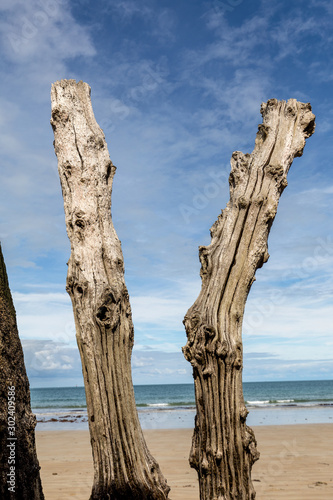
[{"x1": 31, "y1": 380, "x2": 333, "y2": 430}]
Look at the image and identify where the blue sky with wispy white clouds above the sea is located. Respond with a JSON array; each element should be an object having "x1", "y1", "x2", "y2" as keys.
[{"x1": 0, "y1": 0, "x2": 333, "y2": 387}]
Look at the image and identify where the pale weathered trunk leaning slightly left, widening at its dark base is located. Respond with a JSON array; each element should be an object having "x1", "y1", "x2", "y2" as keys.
[{"x1": 51, "y1": 80, "x2": 169, "y2": 500}]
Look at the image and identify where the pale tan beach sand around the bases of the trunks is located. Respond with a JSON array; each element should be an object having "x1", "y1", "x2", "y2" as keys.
[{"x1": 36, "y1": 424, "x2": 333, "y2": 500}]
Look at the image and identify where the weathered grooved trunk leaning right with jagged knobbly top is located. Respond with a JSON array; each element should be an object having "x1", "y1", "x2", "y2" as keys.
[{"x1": 183, "y1": 99, "x2": 315, "y2": 500}]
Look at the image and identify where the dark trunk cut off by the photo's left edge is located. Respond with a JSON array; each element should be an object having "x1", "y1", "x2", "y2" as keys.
[{"x1": 0, "y1": 245, "x2": 44, "y2": 500}]
